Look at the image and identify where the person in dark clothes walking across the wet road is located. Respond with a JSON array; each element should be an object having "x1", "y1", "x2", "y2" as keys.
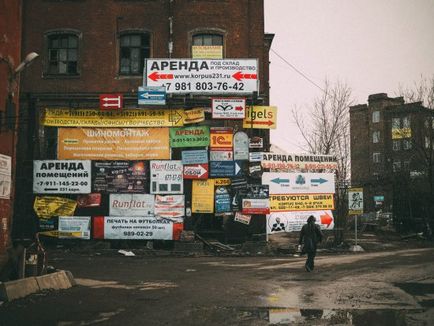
[{"x1": 298, "y1": 215, "x2": 322, "y2": 272}]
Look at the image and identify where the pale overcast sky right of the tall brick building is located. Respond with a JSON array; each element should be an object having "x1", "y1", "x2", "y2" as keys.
[{"x1": 264, "y1": 0, "x2": 434, "y2": 152}]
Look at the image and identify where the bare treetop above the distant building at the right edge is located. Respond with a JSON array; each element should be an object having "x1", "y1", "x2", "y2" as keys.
[{"x1": 398, "y1": 75, "x2": 434, "y2": 110}]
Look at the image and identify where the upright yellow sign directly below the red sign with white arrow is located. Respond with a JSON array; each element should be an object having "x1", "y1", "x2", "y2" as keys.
[{"x1": 191, "y1": 179, "x2": 214, "y2": 213}]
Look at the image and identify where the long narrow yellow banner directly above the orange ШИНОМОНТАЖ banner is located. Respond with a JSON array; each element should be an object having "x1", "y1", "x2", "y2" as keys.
[{"x1": 41, "y1": 108, "x2": 184, "y2": 127}]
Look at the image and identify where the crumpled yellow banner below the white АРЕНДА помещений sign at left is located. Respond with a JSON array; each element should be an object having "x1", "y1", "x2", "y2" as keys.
[{"x1": 33, "y1": 196, "x2": 77, "y2": 219}]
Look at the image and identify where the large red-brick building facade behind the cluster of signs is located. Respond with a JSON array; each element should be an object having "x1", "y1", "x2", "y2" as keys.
[{"x1": 14, "y1": 0, "x2": 273, "y2": 244}]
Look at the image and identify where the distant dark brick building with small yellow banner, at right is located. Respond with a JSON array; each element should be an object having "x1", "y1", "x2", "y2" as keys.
[{"x1": 350, "y1": 93, "x2": 434, "y2": 230}]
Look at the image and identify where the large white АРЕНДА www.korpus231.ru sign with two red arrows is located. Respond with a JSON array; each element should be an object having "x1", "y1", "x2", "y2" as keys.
[{"x1": 143, "y1": 59, "x2": 259, "y2": 94}]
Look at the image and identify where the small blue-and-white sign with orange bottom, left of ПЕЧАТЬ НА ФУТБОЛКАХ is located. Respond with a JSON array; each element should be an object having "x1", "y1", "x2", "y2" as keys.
[{"x1": 59, "y1": 216, "x2": 90, "y2": 240}]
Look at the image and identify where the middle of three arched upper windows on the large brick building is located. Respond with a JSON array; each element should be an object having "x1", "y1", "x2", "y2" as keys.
[{"x1": 119, "y1": 33, "x2": 150, "y2": 75}]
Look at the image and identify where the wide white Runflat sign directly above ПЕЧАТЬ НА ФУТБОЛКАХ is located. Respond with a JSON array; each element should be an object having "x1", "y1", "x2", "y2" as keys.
[{"x1": 109, "y1": 194, "x2": 155, "y2": 216}]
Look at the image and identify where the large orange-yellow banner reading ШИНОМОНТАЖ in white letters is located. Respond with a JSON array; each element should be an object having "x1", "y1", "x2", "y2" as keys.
[{"x1": 57, "y1": 128, "x2": 170, "y2": 161}]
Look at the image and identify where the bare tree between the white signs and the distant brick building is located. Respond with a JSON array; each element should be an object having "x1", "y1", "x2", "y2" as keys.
[{"x1": 292, "y1": 79, "x2": 353, "y2": 243}]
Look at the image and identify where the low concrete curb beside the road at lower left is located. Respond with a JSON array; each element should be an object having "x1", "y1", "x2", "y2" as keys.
[{"x1": 0, "y1": 271, "x2": 77, "y2": 301}]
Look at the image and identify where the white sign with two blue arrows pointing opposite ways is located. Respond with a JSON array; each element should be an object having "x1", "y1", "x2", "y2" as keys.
[{"x1": 262, "y1": 172, "x2": 335, "y2": 194}]
